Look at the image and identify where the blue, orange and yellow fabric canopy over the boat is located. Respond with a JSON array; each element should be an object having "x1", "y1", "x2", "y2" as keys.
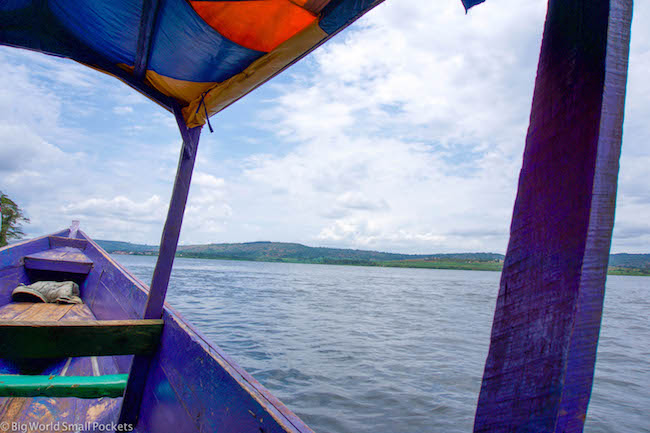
[{"x1": 0, "y1": 0, "x2": 483, "y2": 127}]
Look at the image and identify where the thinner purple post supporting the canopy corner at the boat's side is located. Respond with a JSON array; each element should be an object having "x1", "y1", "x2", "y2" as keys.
[{"x1": 120, "y1": 105, "x2": 202, "y2": 425}]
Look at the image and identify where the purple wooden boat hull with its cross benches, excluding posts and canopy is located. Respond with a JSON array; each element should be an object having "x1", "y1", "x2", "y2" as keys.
[{"x1": 0, "y1": 224, "x2": 311, "y2": 432}]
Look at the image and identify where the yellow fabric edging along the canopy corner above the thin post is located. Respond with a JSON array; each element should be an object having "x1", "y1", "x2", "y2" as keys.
[{"x1": 181, "y1": 22, "x2": 327, "y2": 128}]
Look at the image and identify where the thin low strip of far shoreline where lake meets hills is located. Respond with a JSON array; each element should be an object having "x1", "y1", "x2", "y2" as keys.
[{"x1": 111, "y1": 251, "x2": 650, "y2": 277}]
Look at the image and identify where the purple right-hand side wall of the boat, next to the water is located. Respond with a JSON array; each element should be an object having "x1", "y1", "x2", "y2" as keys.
[{"x1": 73, "y1": 232, "x2": 312, "y2": 433}]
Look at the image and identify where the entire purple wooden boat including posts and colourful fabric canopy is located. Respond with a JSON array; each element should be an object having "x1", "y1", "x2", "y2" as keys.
[{"x1": 0, "y1": 0, "x2": 632, "y2": 433}]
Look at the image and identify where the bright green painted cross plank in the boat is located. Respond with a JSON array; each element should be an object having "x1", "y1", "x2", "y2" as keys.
[{"x1": 0, "y1": 374, "x2": 127, "y2": 398}]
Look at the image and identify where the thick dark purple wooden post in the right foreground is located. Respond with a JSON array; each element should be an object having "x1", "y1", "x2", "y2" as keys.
[{"x1": 474, "y1": 0, "x2": 632, "y2": 433}]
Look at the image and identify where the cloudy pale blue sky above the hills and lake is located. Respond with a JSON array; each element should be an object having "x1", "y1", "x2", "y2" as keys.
[{"x1": 0, "y1": 0, "x2": 650, "y2": 254}]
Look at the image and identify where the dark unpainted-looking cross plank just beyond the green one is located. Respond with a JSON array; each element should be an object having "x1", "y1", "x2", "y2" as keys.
[{"x1": 0, "y1": 318, "x2": 163, "y2": 359}]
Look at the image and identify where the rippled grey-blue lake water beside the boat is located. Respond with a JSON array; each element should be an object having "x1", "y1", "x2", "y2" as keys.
[{"x1": 115, "y1": 256, "x2": 650, "y2": 433}]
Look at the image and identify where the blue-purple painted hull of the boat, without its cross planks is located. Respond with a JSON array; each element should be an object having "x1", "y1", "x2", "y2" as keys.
[{"x1": 0, "y1": 230, "x2": 312, "y2": 433}]
